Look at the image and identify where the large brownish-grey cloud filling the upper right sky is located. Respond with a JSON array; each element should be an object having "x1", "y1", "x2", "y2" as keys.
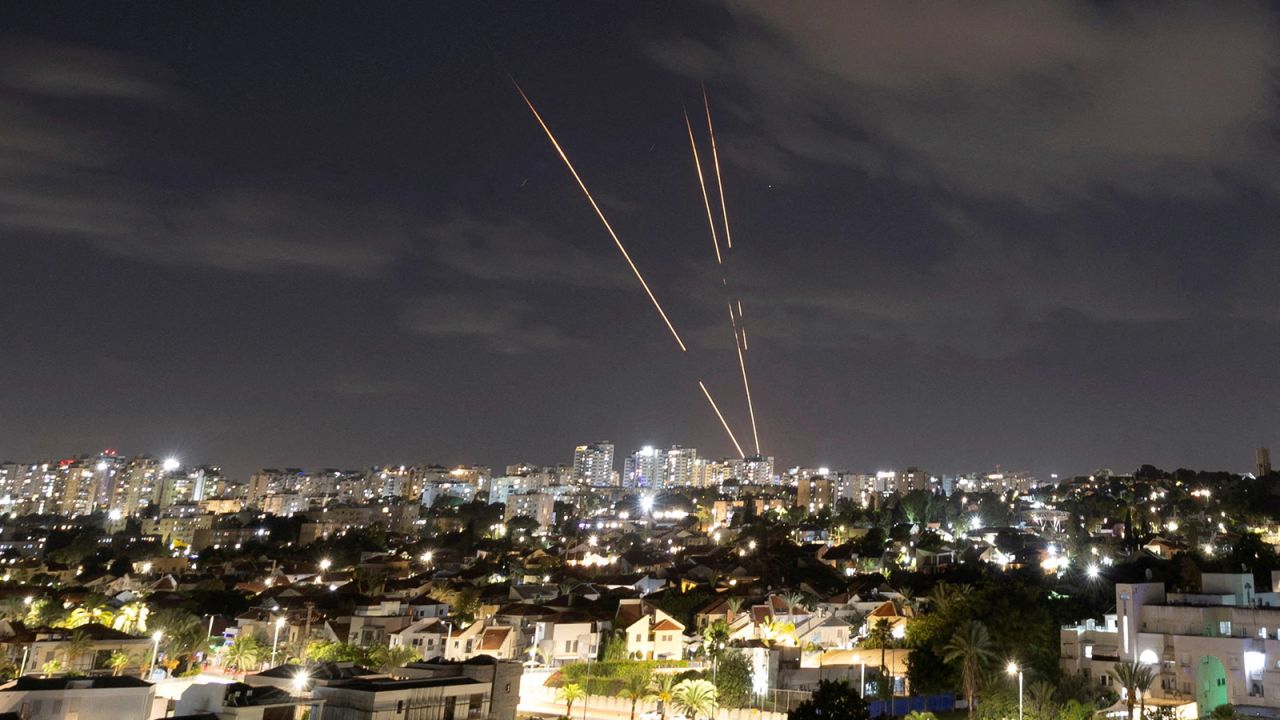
[{"x1": 654, "y1": 0, "x2": 1280, "y2": 206}]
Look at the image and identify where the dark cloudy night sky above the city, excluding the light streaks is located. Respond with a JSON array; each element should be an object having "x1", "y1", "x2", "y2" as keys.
[{"x1": 0, "y1": 0, "x2": 1280, "y2": 477}]
